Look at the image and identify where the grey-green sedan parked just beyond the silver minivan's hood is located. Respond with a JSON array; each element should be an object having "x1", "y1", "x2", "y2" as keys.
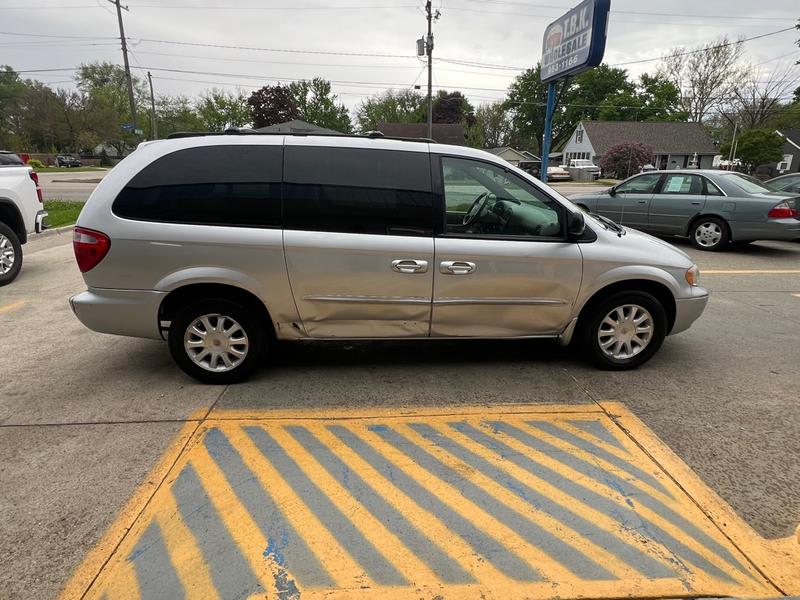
[{"x1": 572, "y1": 169, "x2": 800, "y2": 250}]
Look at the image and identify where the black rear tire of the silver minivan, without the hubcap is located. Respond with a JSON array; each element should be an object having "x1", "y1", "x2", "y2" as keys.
[{"x1": 168, "y1": 298, "x2": 266, "y2": 385}]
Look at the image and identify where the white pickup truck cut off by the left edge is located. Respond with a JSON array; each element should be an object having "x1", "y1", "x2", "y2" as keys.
[{"x1": 0, "y1": 151, "x2": 47, "y2": 286}]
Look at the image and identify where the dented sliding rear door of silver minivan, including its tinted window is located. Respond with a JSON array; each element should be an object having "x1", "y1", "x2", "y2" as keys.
[{"x1": 283, "y1": 137, "x2": 434, "y2": 338}]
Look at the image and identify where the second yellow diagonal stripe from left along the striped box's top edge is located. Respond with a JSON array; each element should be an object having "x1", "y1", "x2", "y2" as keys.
[{"x1": 272, "y1": 429, "x2": 438, "y2": 585}]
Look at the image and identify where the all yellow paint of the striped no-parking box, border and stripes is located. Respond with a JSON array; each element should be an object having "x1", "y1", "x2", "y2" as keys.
[{"x1": 62, "y1": 403, "x2": 800, "y2": 600}]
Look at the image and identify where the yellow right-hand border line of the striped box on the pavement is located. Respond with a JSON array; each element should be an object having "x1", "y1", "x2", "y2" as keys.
[{"x1": 601, "y1": 402, "x2": 800, "y2": 596}]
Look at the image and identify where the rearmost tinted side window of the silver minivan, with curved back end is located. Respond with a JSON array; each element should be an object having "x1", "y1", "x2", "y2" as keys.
[{"x1": 112, "y1": 145, "x2": 283, "y2": 228}]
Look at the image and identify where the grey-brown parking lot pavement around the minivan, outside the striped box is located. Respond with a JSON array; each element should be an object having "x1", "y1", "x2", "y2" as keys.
[{"x1": 0, "y1": 229, "x2": 800, "y2": 598}]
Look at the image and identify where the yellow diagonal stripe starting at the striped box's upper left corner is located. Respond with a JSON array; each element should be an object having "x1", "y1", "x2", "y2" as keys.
[{"x1": 225, "y1": 427, "x2": 369, "y2": 588}]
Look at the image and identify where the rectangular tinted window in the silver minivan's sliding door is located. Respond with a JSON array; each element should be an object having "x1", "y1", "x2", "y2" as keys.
[{"x1": 283, "y1": 146, "x2": 433, "y2": 236}]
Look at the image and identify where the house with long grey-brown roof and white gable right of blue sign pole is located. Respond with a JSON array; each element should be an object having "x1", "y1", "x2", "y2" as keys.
[{"x1": 563, "y1": 121, "x2": 719, "y2": 169}]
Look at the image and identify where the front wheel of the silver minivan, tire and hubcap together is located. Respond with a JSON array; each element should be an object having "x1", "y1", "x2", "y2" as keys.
[{"x1": 581, "y1": 292, "x2": 667, "y2": 370}]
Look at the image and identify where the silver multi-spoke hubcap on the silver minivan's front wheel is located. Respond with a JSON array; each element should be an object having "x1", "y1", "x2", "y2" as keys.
[{"x1": 597, "y1": 304, "x2": 653, "y2": 360}]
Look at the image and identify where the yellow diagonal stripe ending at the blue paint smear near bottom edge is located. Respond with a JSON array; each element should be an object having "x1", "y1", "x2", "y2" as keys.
[{"x1": 188, "y1": 446, "x2": 277, "y2": 600}]
